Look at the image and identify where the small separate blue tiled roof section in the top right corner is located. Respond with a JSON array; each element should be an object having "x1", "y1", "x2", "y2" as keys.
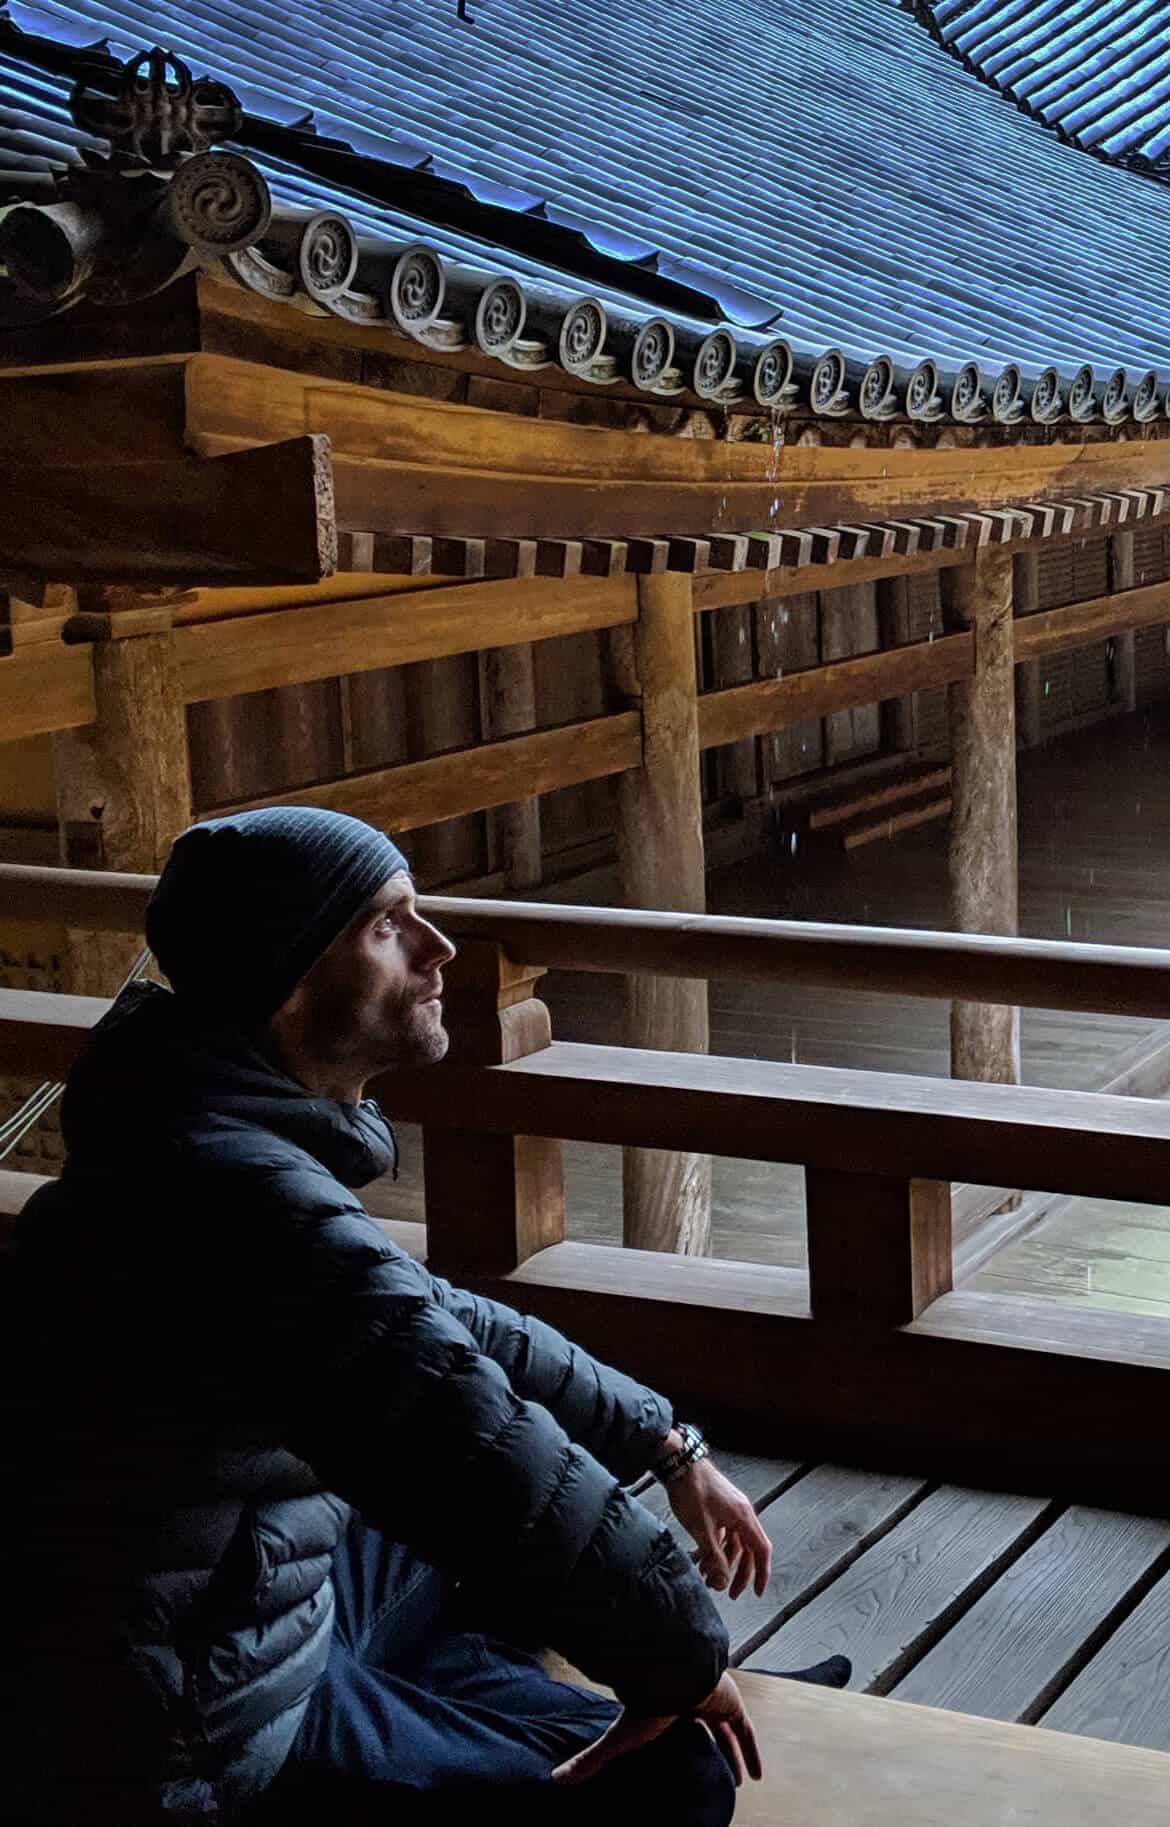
[{"x1": 912, "y1": 0, "x2": 1170, "y2": 170}]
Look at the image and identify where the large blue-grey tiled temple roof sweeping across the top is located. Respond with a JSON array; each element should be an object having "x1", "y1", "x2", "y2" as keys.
[{"x1": 0, "y1": 0, "x2": 1170, "y2": 412}]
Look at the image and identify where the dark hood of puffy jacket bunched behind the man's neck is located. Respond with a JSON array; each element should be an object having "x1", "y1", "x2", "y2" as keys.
[{"x1": 60, "y1": 983, "x2": 397, "y2": 1188}]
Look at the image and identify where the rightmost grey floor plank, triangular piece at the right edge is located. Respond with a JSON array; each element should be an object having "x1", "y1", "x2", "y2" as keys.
[{"x1": 1038, "y1": 1577, "x2": 1170, "y2": 1750}]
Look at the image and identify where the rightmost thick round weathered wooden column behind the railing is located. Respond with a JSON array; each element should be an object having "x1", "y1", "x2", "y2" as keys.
[{"x1": 943, "y1": 550, "x2": 1020, "y2": 1085}]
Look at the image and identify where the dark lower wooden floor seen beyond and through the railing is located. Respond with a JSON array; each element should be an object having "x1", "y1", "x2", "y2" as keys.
[{"x1": 373, "y1": 709, "x2": 1170, "y2": 1317}]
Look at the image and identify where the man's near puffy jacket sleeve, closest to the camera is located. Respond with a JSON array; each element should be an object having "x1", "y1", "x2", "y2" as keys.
[{"x1": 256, "y1": 1211, "x2": 728, "y2": 1714}]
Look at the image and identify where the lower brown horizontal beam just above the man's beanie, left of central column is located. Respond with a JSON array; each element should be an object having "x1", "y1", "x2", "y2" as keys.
[{"x1": 207, "y1": 711, "x2": 642, "y2": 831}]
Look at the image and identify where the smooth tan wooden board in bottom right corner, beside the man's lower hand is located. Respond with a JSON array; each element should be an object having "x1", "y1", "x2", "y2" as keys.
[{"x1": 735, "y1": 1674, "x2": 1170, "y2": 1827}]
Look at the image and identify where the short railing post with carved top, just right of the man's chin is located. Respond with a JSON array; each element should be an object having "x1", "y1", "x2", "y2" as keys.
[{"x1": 416, "y1": 939, "x2": 565, "y2": 1281}]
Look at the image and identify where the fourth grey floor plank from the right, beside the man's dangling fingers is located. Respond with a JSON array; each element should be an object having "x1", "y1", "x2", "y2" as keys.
[{"x1": 717, "y1": 1465, "x2": 927, "y2": 1666}]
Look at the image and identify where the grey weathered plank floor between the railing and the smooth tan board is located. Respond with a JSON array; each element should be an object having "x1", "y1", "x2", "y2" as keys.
[{"x1": 642, "y1": 1452, "x2": 1170, "y2": 1753}]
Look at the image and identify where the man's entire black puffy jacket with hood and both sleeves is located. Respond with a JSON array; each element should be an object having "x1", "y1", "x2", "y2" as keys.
[{"x1": 0, "y1": 987, "x2": 728, "y2": 1827}]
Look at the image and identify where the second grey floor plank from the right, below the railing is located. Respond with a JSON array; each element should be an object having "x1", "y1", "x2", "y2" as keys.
[{"x1": 894, "y1": 1505, "x2": 1170, "y2": 1725}]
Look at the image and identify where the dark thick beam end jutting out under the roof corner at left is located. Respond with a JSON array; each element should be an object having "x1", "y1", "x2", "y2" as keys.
[{"x1": 0, "y1": 437, "x2": 336, "y2": 585}]
